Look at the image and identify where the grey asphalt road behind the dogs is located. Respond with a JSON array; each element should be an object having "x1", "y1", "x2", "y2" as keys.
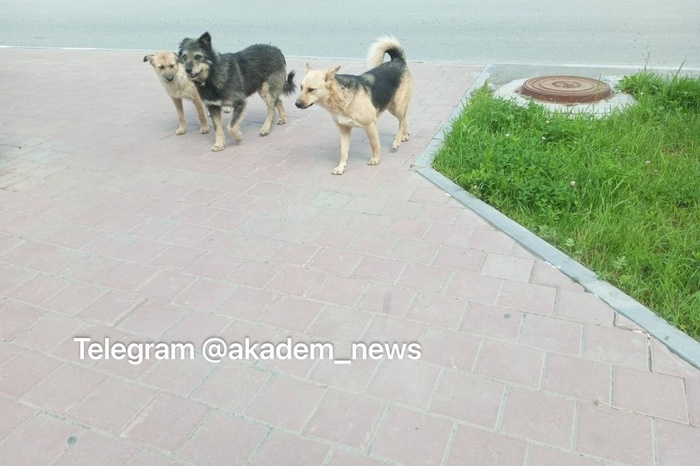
[{"x1": 0, "y1": 0, "x2": 700, "y2": 67}]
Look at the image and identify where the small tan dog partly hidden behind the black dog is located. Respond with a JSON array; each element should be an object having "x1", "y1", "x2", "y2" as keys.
[{"x1": 143, "y1": 52, "x2": 209, "y2": 135}]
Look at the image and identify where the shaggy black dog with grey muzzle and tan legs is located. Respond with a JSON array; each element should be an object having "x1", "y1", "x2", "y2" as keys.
[{"x1": 179, "y1": 32, "x2": 296, "y2": 151}]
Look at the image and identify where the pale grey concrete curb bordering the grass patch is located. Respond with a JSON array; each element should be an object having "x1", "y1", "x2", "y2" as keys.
[{"x1": 414, "y1": 66, "x2": 700, "y2": 369}]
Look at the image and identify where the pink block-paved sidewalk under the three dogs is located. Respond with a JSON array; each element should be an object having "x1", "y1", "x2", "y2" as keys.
[{"x1": 0, "y1": 49, "x2": 700, "y2": 466}]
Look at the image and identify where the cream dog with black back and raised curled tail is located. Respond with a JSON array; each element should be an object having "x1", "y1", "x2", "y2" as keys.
[{"x1": 295, "y1": 37, "x2": 413, "y2": 175}]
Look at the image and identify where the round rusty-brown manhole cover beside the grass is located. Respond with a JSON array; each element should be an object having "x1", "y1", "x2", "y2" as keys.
[{"x1": 520, "y1": 76, "x2": 612, "y2": 104}]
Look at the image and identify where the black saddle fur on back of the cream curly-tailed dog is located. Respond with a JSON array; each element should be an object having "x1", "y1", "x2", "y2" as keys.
[{"x1": 335, "y1": 49, "x2": 407, "y2": 111}]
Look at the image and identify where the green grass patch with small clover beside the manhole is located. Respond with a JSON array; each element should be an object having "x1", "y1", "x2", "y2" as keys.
[{"x1": 434, "y1": 72, "x2": 700, "y2": 339}]
